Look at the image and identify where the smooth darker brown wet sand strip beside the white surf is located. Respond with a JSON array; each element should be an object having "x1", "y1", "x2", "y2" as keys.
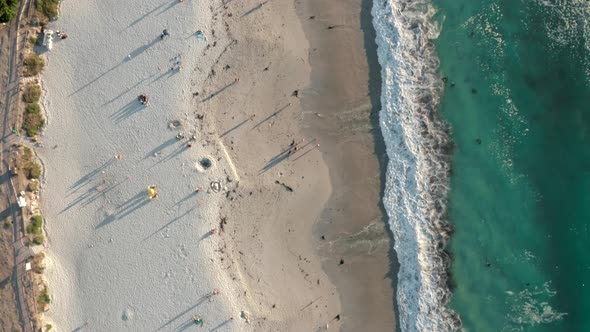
[{"x1": 297, "y1": 0, "x2": 398, "y2": 331}]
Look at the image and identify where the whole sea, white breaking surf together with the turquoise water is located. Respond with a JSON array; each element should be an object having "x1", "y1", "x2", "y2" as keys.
[{"x1": 373, "y1": 0, "x2": 590, "y2": 331}]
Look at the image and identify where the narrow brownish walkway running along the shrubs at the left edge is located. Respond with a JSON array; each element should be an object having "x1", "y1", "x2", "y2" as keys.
[{"x1": 0, "y1": 0, "x2": 33, "y2": 332}]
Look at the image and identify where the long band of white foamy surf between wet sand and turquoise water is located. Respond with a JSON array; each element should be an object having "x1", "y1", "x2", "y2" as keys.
[{"x1": 372, "y1": 0, "x2": 461, "y2": 331}]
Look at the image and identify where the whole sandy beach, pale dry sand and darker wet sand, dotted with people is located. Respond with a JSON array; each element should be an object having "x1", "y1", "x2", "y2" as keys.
[{"x1": 40, "y1": 0, "x2": 396, "y2": 331}]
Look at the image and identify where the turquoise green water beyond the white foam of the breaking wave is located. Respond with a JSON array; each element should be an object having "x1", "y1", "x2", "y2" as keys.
[{"x1": 434, "y1": 0, "x2": 590, "y2": 331}]
